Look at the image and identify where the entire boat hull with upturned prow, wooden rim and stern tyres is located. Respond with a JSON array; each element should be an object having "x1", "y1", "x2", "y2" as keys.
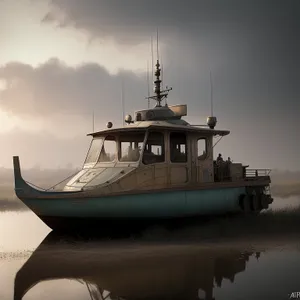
[{"x1": 14, "y1": 157, "x2": 273, "y2": 231}]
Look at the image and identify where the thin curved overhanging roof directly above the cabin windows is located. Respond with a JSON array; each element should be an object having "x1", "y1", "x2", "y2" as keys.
[{"x1": 87, "y1": 121, "x2": 230, "y2": 137}]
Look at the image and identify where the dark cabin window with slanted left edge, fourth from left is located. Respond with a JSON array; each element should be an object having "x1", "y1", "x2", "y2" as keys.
[{"x1": 143, "y1": 132, "x2": 165, "y2": 165}]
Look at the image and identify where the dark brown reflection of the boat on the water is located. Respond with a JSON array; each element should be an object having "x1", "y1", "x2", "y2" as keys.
[{"x1": 14, "y1": 233, "x2": 259, "y2": 300}]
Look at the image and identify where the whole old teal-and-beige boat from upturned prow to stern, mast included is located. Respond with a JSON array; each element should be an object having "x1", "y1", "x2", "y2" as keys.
[{"x1": 13, "y1": 60, "x2": 273, "y2": 231}]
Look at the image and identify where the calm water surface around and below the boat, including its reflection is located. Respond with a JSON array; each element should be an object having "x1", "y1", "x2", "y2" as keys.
[{"x1": 0, "y1": 198, "x2": 300, "y2": 300}]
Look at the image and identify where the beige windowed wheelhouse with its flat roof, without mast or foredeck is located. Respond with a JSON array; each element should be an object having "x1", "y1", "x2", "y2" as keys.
[{"x1": 84, "y1": 124, "x2": 229, "y2": 184}]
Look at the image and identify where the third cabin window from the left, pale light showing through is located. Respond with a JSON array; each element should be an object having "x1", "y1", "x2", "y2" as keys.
[{"x1": 119, "y1": 133, "x2": 145, "y2": 162}]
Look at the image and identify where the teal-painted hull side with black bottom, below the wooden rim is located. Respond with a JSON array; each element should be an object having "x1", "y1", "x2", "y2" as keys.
[{"x1": 22, "y1": 187, "x2": 246, "y2": 230}]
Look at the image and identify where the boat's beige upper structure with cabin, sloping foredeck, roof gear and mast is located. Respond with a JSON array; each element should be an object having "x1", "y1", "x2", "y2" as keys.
[{"x1": 65, "y1": 62, "x2": 243, "y2": 190}]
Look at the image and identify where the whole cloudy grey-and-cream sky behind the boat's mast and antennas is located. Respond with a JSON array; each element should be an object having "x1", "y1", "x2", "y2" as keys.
[{"x1": 0, "y1": 0, "x2": 300, "y2": 170}]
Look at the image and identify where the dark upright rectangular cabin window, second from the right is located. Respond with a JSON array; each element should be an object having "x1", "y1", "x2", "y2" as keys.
[{"x1": 170, "y1": 132, "x2": 187, "y2": 163}]
